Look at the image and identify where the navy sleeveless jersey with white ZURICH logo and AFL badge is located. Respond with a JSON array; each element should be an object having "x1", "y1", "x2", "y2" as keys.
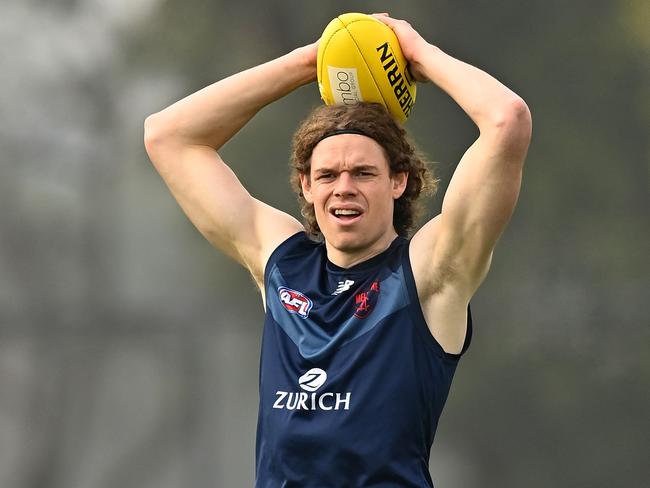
[{"x1": 255, "y1": 232, "x2": 471, "y2": 488}]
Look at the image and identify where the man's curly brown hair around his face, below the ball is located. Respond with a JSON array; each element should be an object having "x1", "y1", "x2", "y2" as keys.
[{"x1": 291, "y1": 102, "x2": 438, "y2": 237}]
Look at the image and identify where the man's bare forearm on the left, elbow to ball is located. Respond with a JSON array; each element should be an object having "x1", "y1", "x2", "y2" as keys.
[{"x1": 145, "y1": 46, "x2": 316, "y2": 149}]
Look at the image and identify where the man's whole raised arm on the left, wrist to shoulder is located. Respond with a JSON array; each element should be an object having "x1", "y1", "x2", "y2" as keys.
[{"x1": 145, "y1": 43, "x2": 317, "y2": 287}]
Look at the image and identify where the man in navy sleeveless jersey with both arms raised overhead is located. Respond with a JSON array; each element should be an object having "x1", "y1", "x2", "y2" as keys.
[{"x1": 145, "y1": 14, "x2": 531, "y2": 487}]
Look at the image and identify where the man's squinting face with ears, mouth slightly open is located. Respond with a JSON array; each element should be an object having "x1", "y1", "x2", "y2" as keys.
[{"x1": 300, "y1": 134, "x2": 406, "y2": 253}]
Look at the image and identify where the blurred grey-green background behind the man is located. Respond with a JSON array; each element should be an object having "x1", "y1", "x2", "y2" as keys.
[{"x1": 0, "y1": 0, "x2": 650, "y2": 488}]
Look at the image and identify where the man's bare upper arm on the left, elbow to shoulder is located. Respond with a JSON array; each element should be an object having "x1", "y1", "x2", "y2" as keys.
[{"x1": 150, "y1": 141, "x2": 302, "y2": 282}]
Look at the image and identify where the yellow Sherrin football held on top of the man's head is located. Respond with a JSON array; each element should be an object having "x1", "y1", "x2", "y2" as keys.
[{"x1": 317, "y1": 13, "x2": 415, "y2": 122}]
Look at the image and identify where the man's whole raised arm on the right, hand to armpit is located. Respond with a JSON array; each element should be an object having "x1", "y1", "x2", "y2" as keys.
[{"x1": 378, "y1": 16, "x2": 531, "y2": 352}]
